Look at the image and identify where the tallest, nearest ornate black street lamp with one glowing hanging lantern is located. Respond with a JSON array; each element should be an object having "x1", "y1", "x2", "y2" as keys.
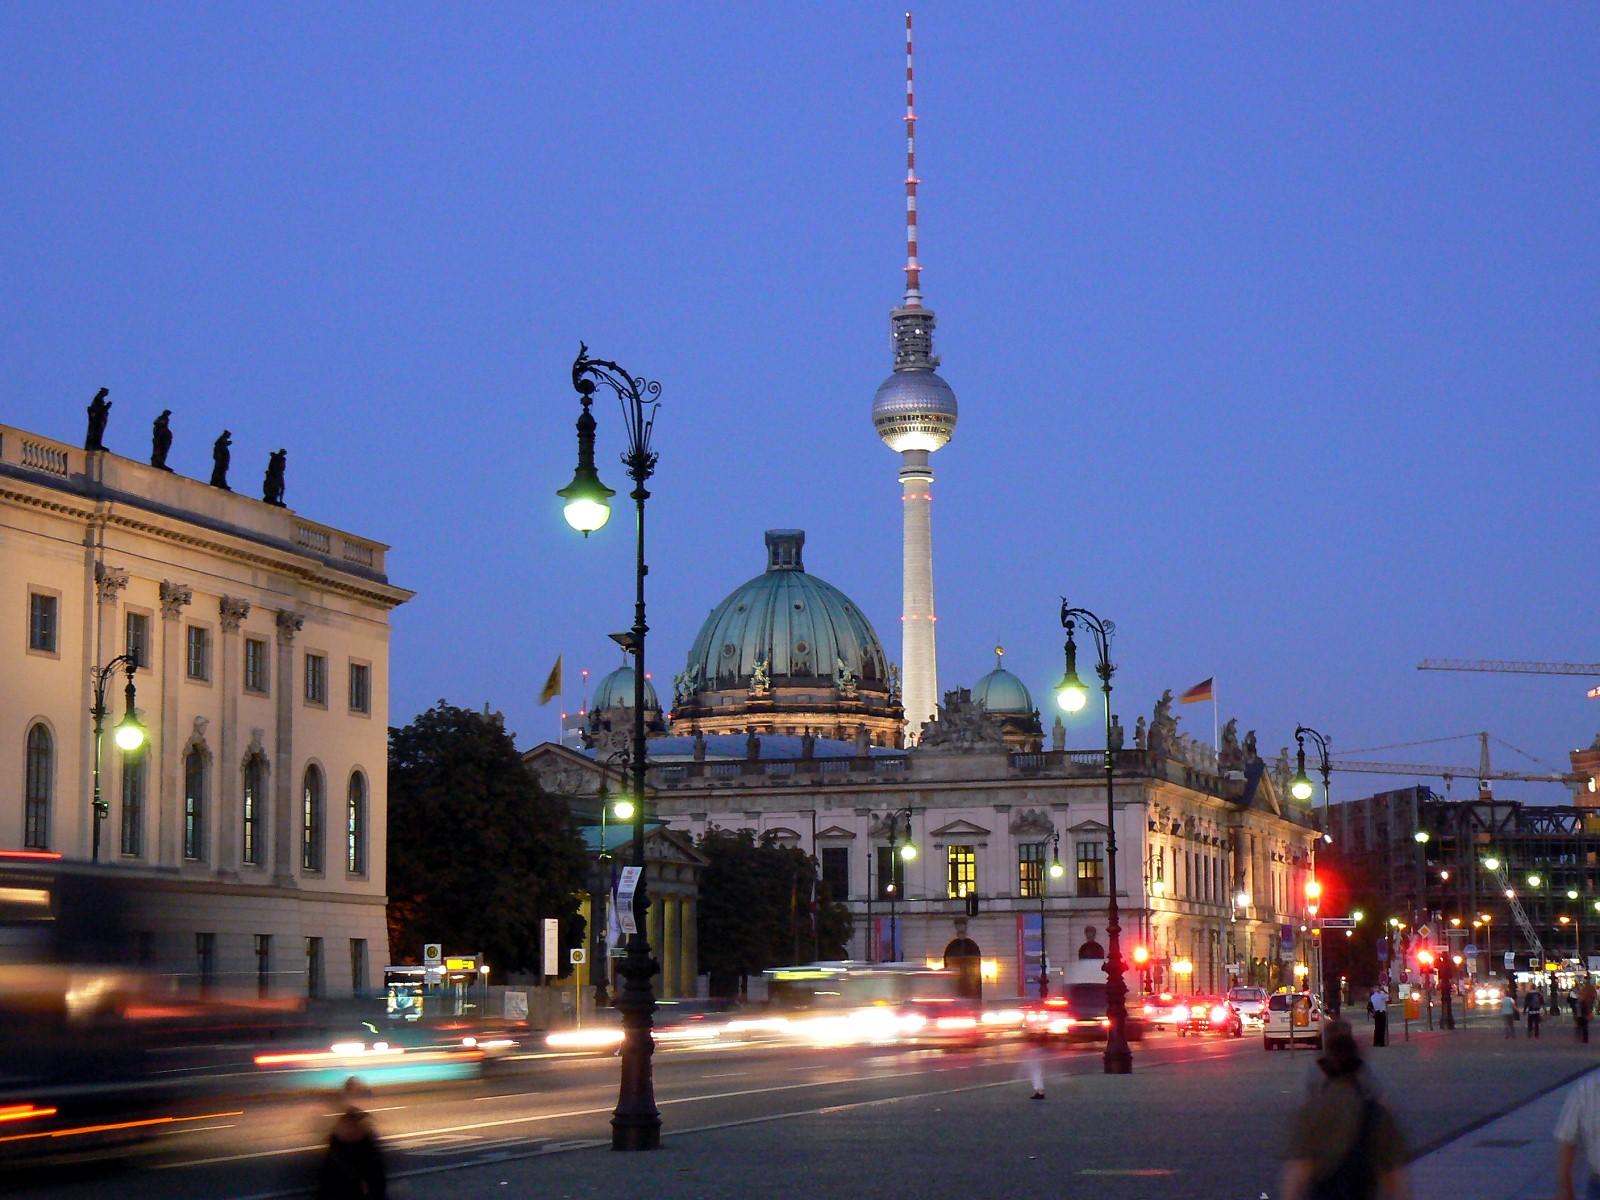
[{"x1": 557, "y1": 342, "x2": 661, "y2": 1150}]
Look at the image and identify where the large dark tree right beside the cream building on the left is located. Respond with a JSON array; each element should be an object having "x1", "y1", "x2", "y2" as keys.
[{"x1": 389, "y1": 701, "x2": 587, "y2": 973}]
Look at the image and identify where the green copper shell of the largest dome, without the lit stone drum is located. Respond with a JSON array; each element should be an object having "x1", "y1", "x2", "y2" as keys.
[{"x1": 683, "y1": 530, "x2": 888, "y2": 693}]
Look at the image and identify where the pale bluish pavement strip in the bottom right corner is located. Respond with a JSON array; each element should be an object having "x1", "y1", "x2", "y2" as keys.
[{"x1": 1411, "y1": 1083, "x2": 1584, "y2": 1200}]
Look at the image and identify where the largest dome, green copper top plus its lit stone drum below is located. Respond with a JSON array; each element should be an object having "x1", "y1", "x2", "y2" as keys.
[{"x1": 672, "y1": 530, "x2": 904, "y2": 746}]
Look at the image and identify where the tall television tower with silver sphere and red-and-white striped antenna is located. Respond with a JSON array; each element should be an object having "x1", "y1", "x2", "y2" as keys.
[{"x1": 872, "y1": 13, "x2": 955, "y2": 744}]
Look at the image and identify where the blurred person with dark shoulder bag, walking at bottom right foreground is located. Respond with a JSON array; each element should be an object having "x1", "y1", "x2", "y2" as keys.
[{"x1": 1282, "y1": 1029, "x2": 1406, "y2": 1200}]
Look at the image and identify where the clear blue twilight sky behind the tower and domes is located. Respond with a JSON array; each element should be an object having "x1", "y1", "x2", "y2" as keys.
[{"x1": 0, "y1": 3, "x2": 1600, "y2": 800}]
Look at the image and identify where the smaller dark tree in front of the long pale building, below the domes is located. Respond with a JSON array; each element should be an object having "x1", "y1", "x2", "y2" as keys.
[{"x1": 698, "y1": 826, "x2": 850, "y2": 995}]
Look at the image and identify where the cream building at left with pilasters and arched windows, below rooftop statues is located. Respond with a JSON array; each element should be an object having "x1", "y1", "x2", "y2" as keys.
[{"x1": 0, "y1": 426, "x2": 411, "y2": 995}]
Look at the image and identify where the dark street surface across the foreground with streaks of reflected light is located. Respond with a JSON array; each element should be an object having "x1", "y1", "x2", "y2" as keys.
[{"x1": 3, "y1": 1029, "x2": 1600, "y2": 1200}]
